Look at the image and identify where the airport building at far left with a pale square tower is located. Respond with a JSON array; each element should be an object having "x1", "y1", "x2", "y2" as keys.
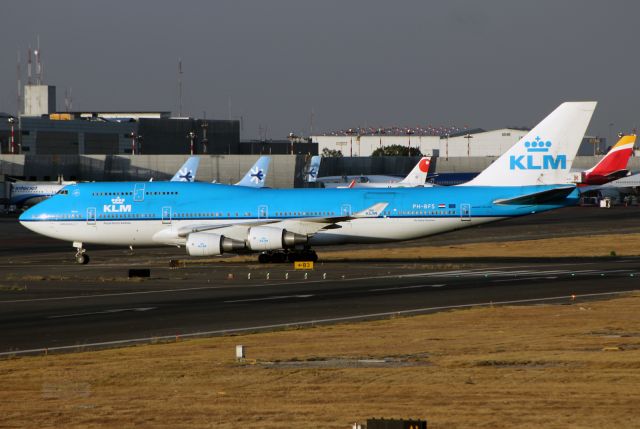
[{"x1": 0, "y1": 84, "x2": 240, "y2": 155}]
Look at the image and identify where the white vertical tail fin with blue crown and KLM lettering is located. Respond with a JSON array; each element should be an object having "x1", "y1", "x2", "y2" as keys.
[{"x1": 460, "y1": 101, "x2": 597, "y2": 186}]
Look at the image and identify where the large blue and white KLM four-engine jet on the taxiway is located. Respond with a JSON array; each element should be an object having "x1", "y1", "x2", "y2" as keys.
[{"x1": 19, "y1": 102, "x2": 596, "y2": 264}]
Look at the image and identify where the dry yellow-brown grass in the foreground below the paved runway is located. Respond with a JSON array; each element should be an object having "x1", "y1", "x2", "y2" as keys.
[{"x1": 0, "y1": 295, "x2": 640, "y2": 428}]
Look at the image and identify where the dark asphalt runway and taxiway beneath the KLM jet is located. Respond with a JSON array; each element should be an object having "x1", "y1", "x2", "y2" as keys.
[{"x1": 0, "y1": 208, "x2": 640, "y2": 356}]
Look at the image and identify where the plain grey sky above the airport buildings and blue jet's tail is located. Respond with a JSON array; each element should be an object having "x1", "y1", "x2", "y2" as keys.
[{"x1": 0, "y1": 0, "x2": 640, "y2": 138}]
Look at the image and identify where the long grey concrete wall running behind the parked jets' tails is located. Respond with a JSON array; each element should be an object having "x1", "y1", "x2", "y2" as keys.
[{"x1": 0, "y1": 155, "x2": 640, "y2": 188}]
